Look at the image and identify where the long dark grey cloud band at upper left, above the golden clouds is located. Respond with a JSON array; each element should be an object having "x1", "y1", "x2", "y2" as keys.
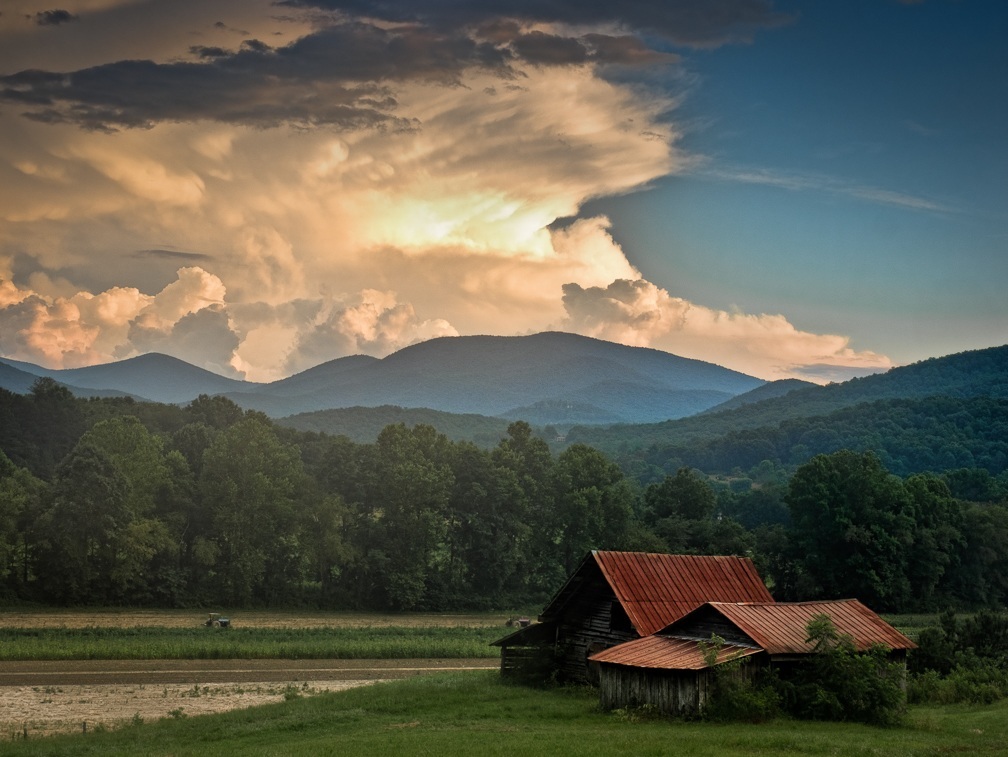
[{"x1": 0, "y1": 23, "x2": 513, "y2": 131}]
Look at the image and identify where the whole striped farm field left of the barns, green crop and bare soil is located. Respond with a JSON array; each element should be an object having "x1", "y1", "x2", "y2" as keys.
[{"x1": 0, "y1": 610, "x2": 508, "y2": 741}]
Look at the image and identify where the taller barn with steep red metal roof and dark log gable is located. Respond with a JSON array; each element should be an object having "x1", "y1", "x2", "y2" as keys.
[{"x1": 494, "y1": 550, "x2": 773, "y2": 683}]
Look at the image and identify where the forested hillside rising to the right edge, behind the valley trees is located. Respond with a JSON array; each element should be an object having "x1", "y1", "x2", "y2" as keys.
[{"x1": 568, "y1": 346, "x2": 1008, "y2": 473}]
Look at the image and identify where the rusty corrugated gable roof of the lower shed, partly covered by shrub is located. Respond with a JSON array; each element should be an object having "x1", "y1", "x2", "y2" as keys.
[{"x1": 681, "y1": 600, "x2": 916, "y2": 654}]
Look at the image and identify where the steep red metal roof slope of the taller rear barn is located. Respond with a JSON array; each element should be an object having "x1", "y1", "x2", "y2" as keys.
[{"x1": 592, "y1": 550, "x2": 773, "y2": 636}]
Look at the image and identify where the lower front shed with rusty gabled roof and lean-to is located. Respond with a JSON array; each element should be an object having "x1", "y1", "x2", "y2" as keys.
[{"x1": 591, "y1": 600, "x2": 915, "y2": 715}]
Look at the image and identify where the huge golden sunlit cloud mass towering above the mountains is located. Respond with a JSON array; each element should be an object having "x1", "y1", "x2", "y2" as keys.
[{"x1": 0, "y1": 0, "x2": 889, "y2": 380}]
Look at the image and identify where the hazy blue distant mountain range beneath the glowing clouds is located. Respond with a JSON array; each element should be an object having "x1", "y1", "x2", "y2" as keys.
[{"x1": 0, "y1": 332, "x2": 765, "y2": 423}]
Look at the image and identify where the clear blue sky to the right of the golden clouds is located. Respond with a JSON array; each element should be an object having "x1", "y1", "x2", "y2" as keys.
[{"x1": 589, "y1": 0, "x2": 1008, "y2": 370}]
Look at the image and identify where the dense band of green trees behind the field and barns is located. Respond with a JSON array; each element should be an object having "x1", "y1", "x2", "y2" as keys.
[{"x1": 0, "y1": 378, "x2": 1008, "y2": 611}]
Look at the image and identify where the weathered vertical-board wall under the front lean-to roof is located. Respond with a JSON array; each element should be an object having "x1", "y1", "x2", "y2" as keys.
[{"x1": 599, "y1": 663, "x2": 714, "y2": 716}]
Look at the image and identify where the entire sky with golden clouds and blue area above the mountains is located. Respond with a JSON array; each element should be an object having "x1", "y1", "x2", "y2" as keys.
[{"x1": 0, "y1": 0, "x2": 1008, "y2": 383}]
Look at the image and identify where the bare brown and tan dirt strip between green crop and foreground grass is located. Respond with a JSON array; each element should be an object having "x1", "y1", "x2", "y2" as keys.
[{"x1": 0, "y1": 659, "x2": 498, "y2": 742}]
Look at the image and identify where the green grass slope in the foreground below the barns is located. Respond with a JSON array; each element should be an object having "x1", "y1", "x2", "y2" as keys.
[{"x1": 3, "y1": 672, "x2": 1008, "y2": 757}]
